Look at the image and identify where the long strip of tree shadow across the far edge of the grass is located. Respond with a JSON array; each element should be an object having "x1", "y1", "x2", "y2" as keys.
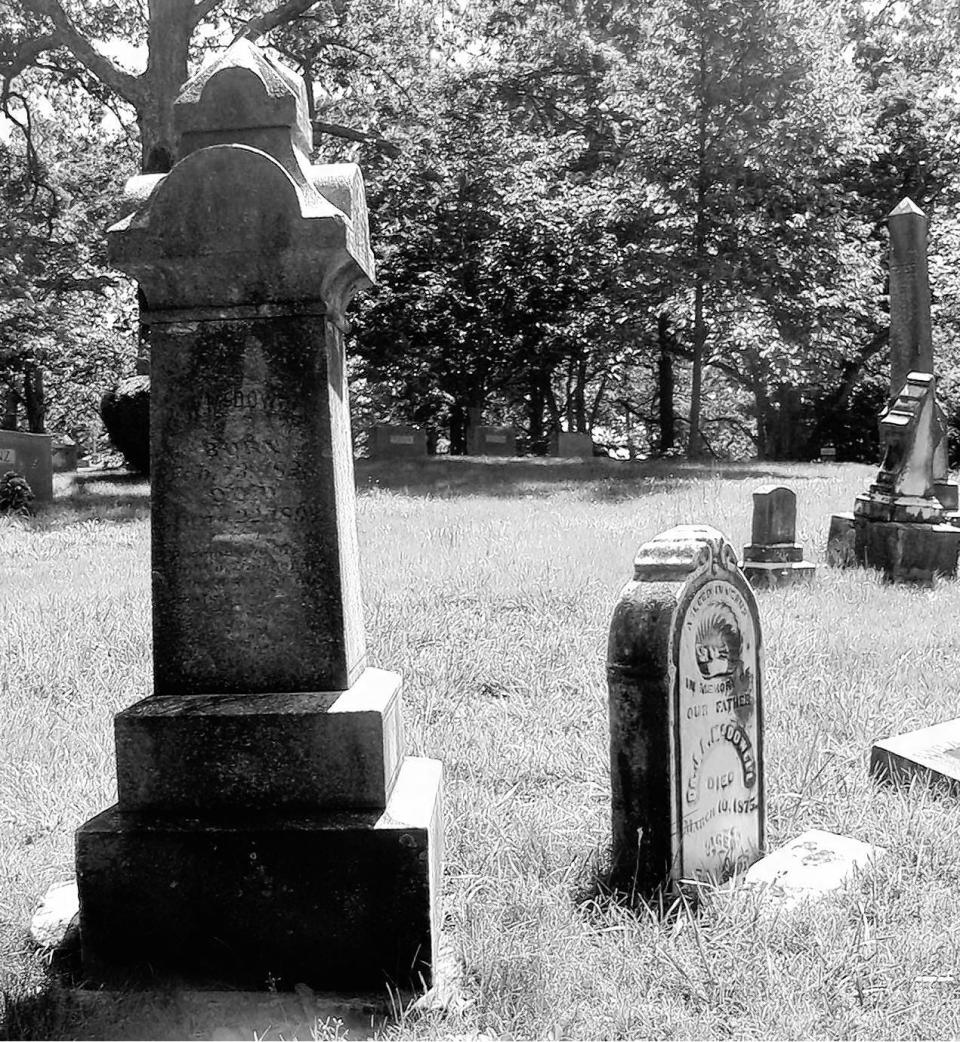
[{"x1": 355, "y1": 456, "x2": 819, "y2": 502}]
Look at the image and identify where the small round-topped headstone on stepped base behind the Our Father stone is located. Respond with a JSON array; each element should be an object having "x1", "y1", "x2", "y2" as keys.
[{"x1": 743, "y1": 485, "x2": 816, "y2": 587}]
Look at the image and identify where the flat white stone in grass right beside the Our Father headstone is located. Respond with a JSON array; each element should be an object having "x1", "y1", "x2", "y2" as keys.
[{"x1": 743, "y1": 828, "x2": 884, "y2": 908}]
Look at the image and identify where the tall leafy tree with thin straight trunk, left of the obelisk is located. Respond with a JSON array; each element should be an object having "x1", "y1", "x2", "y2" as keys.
[{"x1": 618, "y1": 0, "x2": 883, "y2": 456}]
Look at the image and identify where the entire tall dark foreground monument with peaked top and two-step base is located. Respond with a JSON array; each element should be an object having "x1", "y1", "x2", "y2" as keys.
[{"x1": 76, "y1": 41, "x2": 441, "y2": 988}]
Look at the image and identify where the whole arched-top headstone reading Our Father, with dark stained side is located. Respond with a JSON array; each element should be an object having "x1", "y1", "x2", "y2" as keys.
[{"x1": 607, "y1": 525, "x2": 764, "y2": 894}]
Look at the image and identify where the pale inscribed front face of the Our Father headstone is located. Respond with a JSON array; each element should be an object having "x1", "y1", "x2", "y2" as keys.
[{"x1": 672, "y1": 562, "x2": 763, "y2": 880}]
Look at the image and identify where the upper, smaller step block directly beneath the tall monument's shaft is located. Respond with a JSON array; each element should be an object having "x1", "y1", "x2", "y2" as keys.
[{"x1": 114, "y1": 668, "x2": 403, "y2": 816}]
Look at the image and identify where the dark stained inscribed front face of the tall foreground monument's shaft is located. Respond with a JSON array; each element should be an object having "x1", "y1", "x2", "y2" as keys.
[{"x1": 153, "y1": 312, "x2": 354, "y2": 693}]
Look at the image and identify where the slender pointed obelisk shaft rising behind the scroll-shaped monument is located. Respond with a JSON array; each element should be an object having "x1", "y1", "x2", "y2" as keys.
[{"x1": 887, "y1": 198, "x2": 933, "y2": 398}]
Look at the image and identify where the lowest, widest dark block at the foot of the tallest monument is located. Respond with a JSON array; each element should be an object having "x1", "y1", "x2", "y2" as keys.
[{"x1": 76, "y1": 758, "x2": 442, "y2": 989}]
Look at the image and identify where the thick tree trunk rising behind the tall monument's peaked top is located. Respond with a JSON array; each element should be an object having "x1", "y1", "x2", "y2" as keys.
[{"x1": 137, "y1": 0, "x2": 194, "y2": 174}]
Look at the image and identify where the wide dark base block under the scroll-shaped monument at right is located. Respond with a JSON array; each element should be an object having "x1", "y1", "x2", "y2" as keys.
[{"x1": 827, "y1": 514, "x2": 960, "y2": 582}]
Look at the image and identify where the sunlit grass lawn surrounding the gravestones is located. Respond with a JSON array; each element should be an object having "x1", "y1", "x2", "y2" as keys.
[{"x1": 0, "y1": 461, "x2": 960, "y2": 1039}]
